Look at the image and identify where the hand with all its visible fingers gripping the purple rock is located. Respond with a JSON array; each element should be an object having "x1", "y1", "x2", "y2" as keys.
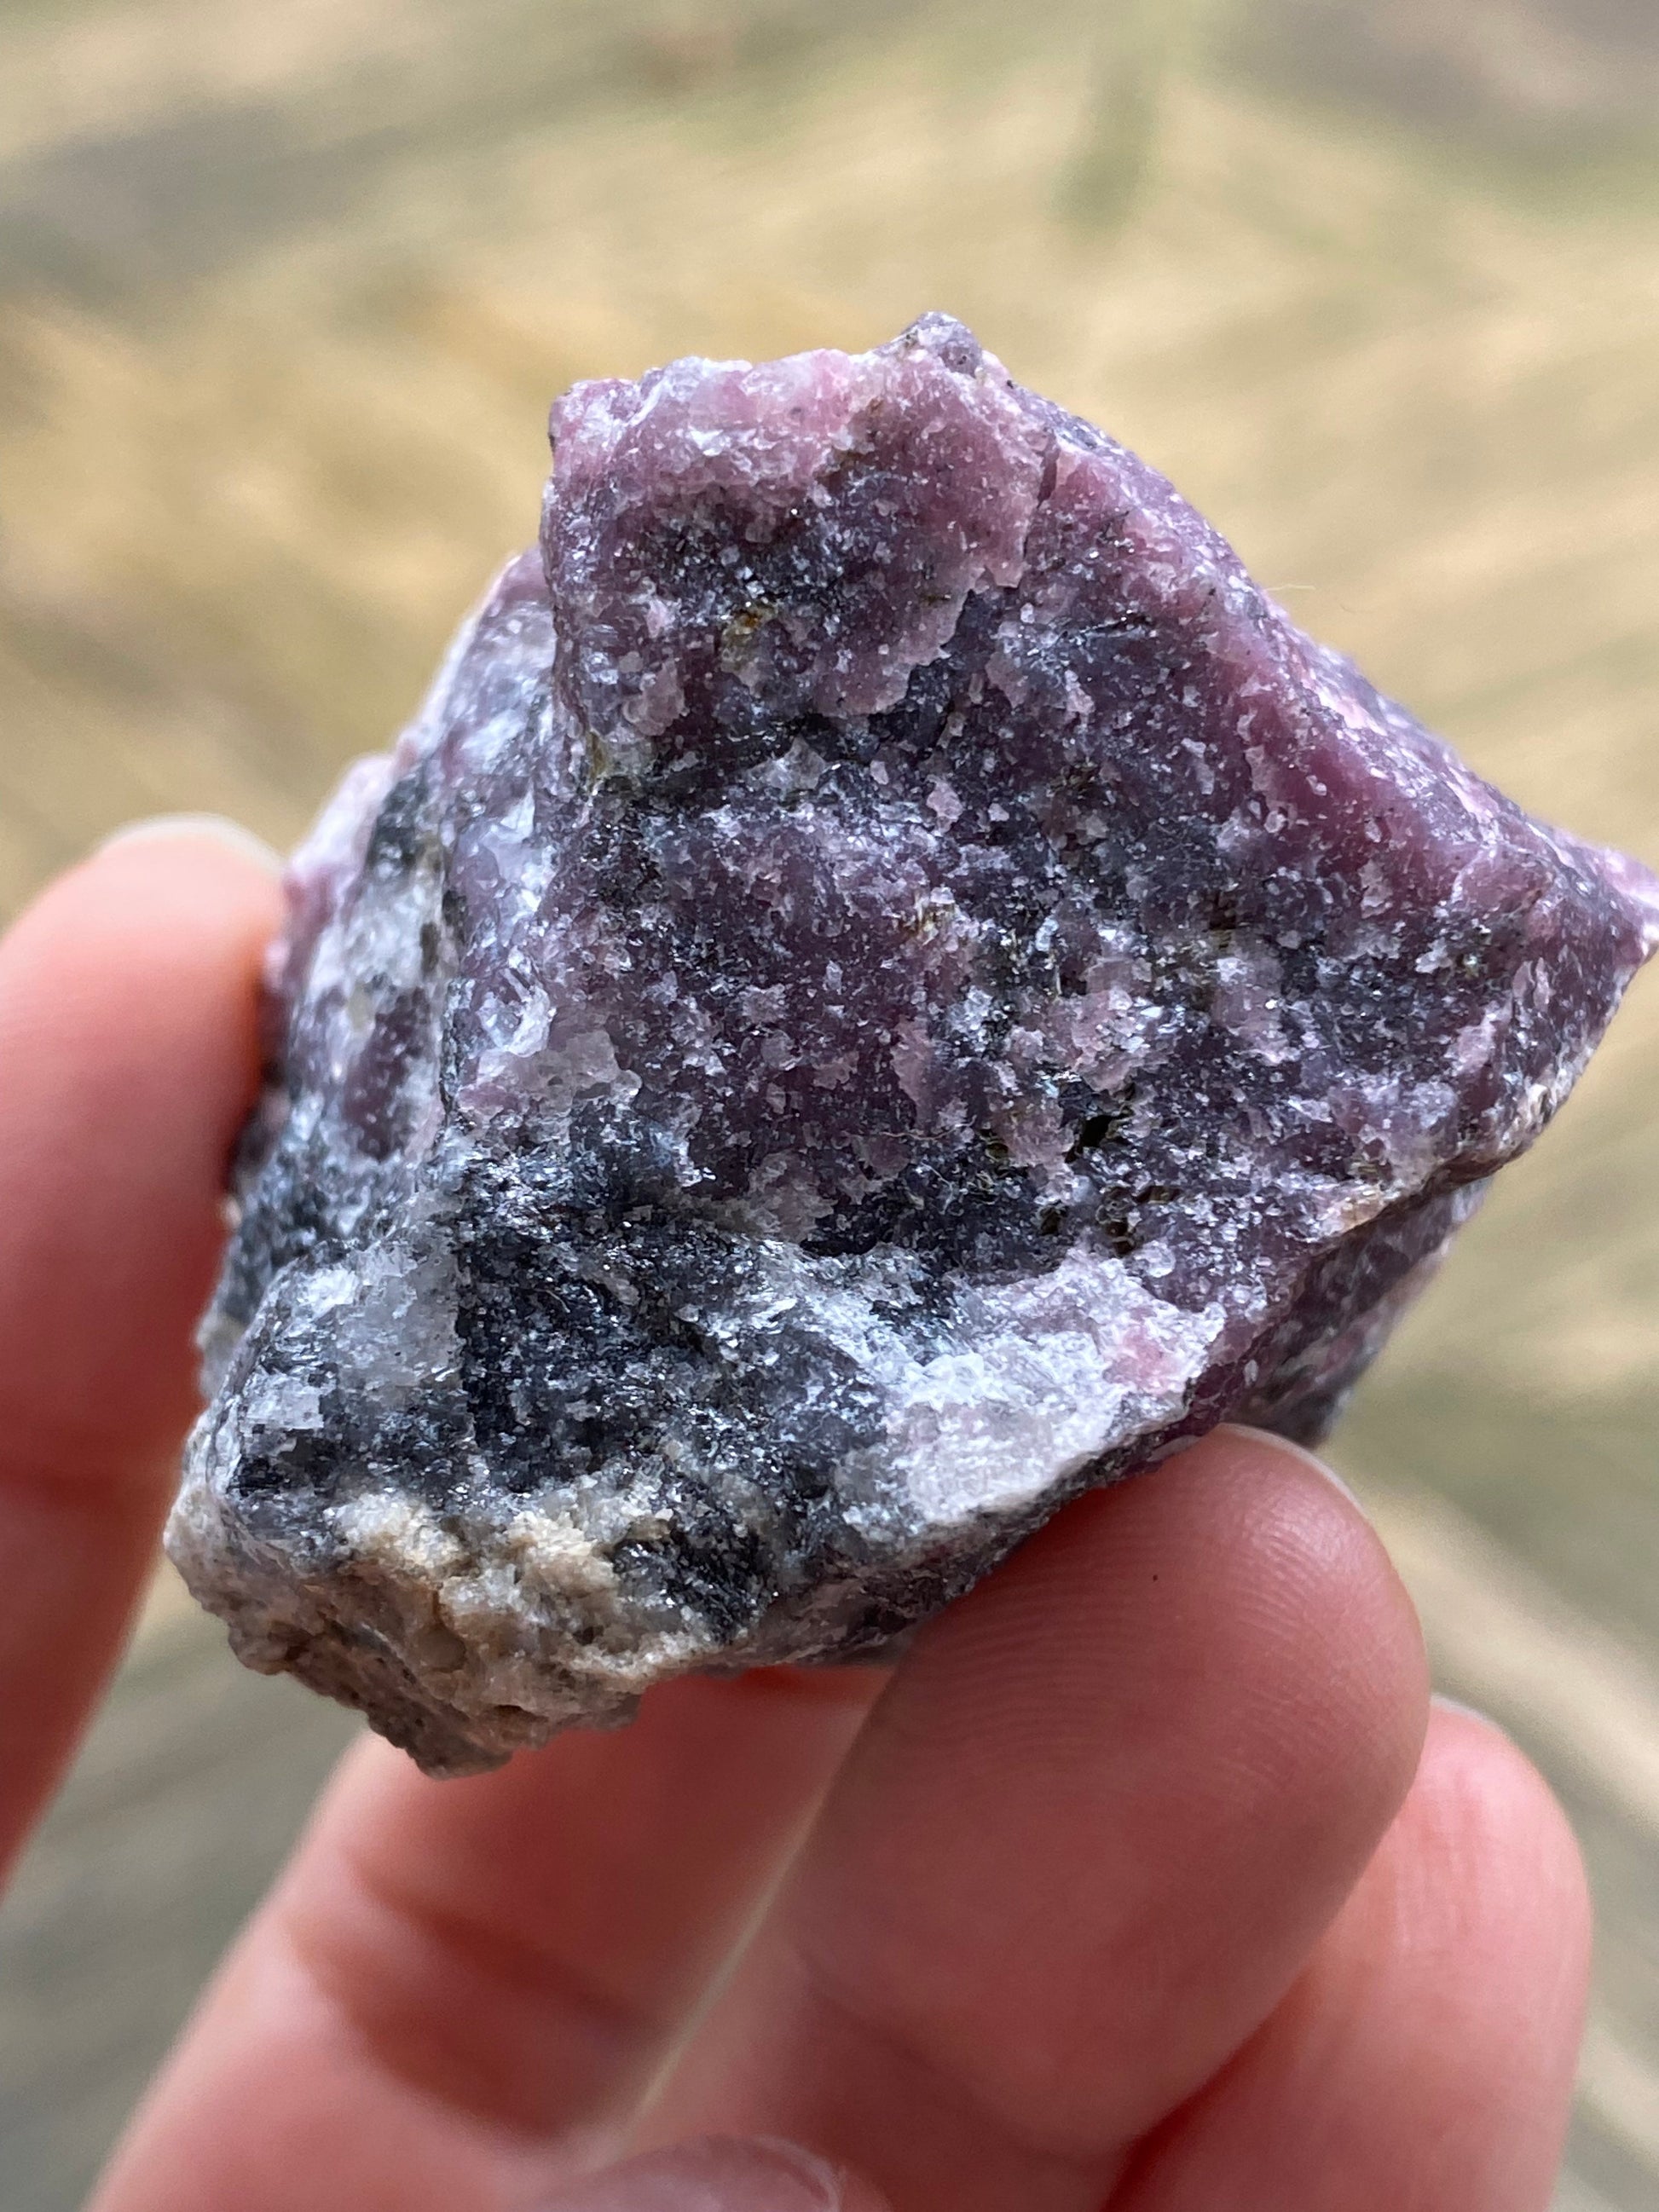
[{"x1": 0, "y1": 829, "x2": 1588, "y2": 2212}]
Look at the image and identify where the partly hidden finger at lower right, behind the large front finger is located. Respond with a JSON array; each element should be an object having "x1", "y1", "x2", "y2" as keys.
[{"x1": 1113, "y1": 1707, "x2": 1591, "y2": 2212}]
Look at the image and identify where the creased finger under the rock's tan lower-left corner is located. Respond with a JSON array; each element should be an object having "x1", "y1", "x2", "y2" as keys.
[{"x1": 97, "y1": 1668, "x2": 878, "y2": 2212}]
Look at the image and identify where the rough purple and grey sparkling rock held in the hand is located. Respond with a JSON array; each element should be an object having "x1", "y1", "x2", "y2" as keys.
[{"x1": 171, "y1": 316, "x2": 1659, "y2": 1774}]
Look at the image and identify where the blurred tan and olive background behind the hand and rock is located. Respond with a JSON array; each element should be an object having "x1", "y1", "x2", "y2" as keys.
[{"x1": 0, "y1": 0, "x2": 1659, "y2": 2212}]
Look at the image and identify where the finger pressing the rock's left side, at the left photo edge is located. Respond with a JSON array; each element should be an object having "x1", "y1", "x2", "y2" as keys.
[{"x1": 0, "y1": 825, "x2": 279, "y2": 1867}]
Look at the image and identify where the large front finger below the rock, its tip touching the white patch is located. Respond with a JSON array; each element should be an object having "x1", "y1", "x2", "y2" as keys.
[{"x1": 641, "y1": 1431, "x2": 1427, "y2": 2212}]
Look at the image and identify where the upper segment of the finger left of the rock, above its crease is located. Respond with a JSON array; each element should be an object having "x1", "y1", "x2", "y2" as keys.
[{"x1": 0, "y1": 828, "x2": 281, "y2": 1462}]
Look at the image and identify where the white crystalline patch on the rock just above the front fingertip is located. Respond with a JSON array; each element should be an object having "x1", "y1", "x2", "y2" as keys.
[{"x1": 887, "y1": 1252, "x2": 1223, "y2": 1524}]
